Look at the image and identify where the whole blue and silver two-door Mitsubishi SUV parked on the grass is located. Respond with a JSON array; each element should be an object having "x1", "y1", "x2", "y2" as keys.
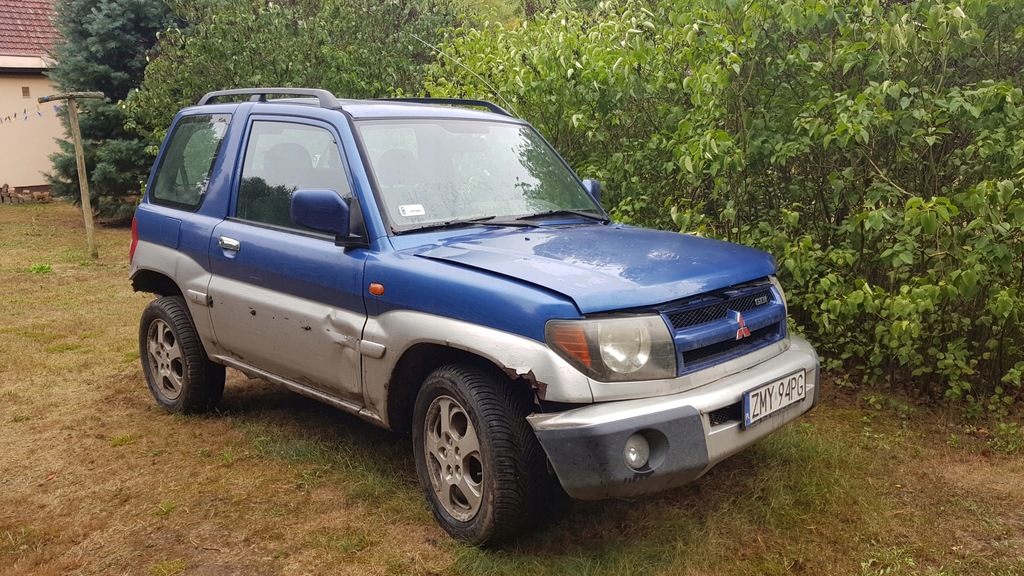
[{"x1": 130, "y1": 88, "x2": 819, "y2": 544}]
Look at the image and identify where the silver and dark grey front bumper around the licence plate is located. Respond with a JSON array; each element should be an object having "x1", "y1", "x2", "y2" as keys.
[{"x1": 527, "y1": 337, "x2": 819, "y2": 500}]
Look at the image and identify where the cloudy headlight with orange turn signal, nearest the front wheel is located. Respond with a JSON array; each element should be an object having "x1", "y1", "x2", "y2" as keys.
[{"x1": 545, "y1": 316, "x2": 676, "y2": 381}]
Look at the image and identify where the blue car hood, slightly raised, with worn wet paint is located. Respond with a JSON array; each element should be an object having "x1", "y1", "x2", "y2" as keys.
[{"x1": 411, "y1": 224, "x2": 775, "y2": 314}]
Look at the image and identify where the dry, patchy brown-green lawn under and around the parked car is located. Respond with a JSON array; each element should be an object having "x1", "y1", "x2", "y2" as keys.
[{"x1": 0, "y1": 203, "x2": 1024, "y2": 576}]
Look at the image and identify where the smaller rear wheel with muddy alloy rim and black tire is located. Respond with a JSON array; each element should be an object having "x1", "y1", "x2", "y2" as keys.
[{"x1": 138, "y1": 296, "x2": 224, "y2": 414}]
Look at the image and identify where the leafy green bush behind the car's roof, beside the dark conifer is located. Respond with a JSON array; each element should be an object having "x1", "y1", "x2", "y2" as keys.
[{"x1": 124, "y1": 0, "x2": 459, "y2": 142}]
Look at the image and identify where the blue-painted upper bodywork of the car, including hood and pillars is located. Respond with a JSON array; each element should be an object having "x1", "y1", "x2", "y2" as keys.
[{"x1": 136, "y1": 95, "x2": 775, "y2": 345}]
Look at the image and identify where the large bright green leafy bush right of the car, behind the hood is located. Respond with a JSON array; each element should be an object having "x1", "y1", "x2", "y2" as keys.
[{"x1": 426, "y1": 0, "x2": 1024, "y2": 416}]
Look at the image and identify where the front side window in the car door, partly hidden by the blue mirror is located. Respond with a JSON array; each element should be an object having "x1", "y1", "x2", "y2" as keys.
[{"x1": 236, "y1": 121, "x2": 352, "y2": 229}]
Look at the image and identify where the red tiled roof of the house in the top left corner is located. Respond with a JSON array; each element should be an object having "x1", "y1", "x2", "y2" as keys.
[{"x1": 0, "y1": 0, "x2": 57, "y2": 56}]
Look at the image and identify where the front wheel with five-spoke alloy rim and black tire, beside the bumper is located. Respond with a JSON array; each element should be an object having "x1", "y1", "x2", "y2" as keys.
[{"x1": 413, "y1": 365, "x2": 548, "y2": 545}]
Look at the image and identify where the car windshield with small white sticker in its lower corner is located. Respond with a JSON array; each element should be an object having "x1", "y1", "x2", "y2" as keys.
[{"x1": 357, "y1": 119, "x2": 604, "y2": 234}]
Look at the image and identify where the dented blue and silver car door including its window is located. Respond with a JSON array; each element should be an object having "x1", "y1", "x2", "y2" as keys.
[{"x1": 209, "y1": 117, "x2": 367, "y2": 405}]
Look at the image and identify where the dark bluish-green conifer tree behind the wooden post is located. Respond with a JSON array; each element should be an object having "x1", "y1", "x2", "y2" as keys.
[{"x1": 47, "y1": 0, "x2": 174, "y2": 220}]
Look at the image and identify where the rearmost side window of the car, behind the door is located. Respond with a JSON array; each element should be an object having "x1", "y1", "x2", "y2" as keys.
[{"x1": 150, "y1": 114, "x2": 231, "y2": 210}]
